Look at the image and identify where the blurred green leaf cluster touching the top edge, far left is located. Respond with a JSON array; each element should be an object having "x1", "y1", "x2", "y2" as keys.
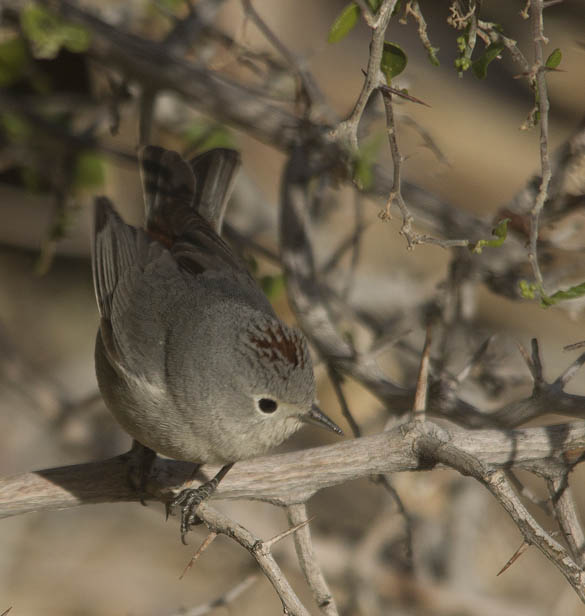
[{"x1": 20, "y1": 3, "x2": 90, "y2": 60}]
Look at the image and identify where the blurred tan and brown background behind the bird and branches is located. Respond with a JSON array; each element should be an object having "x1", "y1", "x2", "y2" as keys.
[{"x1": 0, "y1": 0, "x2": 585, "y2": 616}]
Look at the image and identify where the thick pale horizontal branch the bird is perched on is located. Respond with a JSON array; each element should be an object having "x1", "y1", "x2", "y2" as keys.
[{"x1": 0, "y1": 421, "x2": 585, "y2": 518}]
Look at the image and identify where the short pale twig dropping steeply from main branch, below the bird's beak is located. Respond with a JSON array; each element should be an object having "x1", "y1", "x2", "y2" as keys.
[{"x1": 286, "y1": 504, "x2": 339, "y2": 616}]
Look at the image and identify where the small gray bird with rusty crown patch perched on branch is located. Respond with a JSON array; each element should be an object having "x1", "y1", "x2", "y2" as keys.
[{"x1": 92, "y1": 146, "x2": 341, "y2": 535}]
